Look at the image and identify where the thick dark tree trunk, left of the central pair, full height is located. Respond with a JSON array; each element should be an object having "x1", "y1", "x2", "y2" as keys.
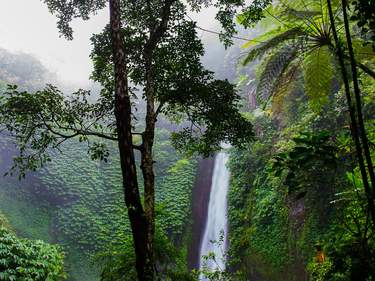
[{"x1": 109, "y1": 0, "x2": 153, "y2": 281}]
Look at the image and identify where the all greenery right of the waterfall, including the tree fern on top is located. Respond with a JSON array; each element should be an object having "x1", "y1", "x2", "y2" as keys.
[{"x1": 229, "y1": 1, "x2": 375, "y2": 280}]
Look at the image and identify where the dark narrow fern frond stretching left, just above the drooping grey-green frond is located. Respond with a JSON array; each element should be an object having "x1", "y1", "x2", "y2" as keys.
[{"x1": 242, "y1": 28, "x2": 305, "y2": 65}]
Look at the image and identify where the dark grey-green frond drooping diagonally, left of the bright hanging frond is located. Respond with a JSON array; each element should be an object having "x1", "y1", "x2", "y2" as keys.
[{"x1": 257, "y1": 44, "x2": 298, "y2": 100}]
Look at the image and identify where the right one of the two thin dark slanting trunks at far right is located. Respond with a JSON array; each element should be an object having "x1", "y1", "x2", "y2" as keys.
[{"x1": 341, "y1": 0, "x2": 375, "y2": 190}]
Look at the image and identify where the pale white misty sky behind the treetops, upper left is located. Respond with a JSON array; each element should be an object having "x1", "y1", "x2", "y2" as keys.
[{"x1": 0, "y1": 0, "x2": 222, "y2": 86}]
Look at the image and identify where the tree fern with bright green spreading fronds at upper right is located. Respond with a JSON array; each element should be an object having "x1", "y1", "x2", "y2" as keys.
[{"x1": 243, "y1": 0, "x2": 375, "y2": 114}]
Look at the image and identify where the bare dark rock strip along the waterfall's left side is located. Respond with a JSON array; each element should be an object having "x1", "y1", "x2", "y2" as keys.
[{"x1": 188, "y1": 158, "x2": 214, "y2": 269}]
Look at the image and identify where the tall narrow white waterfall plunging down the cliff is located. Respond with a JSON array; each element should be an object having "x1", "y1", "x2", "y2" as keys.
[{"x1": 199, "y1": 152, "x2": 230, "y2": 276}]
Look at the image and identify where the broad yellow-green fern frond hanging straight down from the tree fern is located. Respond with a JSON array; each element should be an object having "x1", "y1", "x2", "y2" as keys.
[{"x1": 303, "y1": 46, "x2": 334, "y2": 111}]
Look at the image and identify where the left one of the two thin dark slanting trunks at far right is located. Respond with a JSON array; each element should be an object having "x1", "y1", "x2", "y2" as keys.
[{"x1": 327, "y1": 0, "x2": 375, "y2": 223}]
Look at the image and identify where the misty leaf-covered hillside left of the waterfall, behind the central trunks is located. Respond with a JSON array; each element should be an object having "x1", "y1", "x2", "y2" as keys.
[{"x1": 0, "y1": 129, "x2": 196, "y2": 281}]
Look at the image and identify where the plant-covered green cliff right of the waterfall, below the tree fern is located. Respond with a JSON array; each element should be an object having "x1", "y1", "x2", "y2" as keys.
[{"x1": 229, "y1": 96, "x2": 374, "y2": 280}]
